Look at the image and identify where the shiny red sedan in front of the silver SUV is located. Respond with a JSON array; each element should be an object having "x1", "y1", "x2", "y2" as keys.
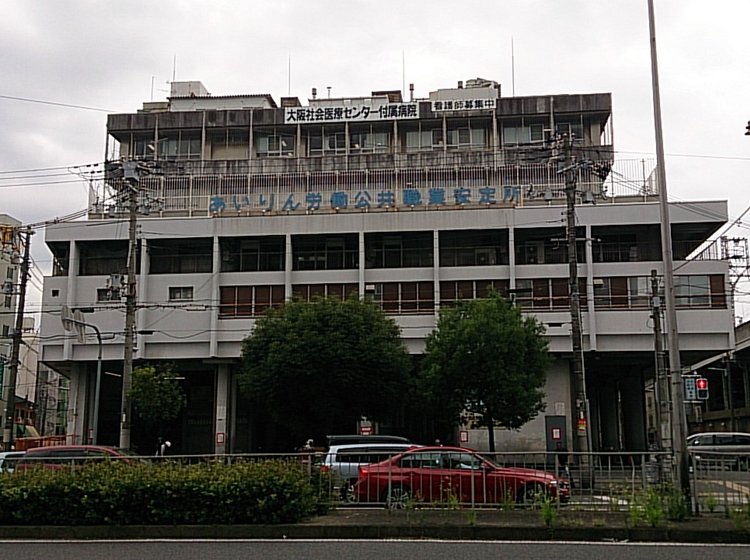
[{"x1": 354, "y1": 447, "x2": 570, "y2": 508}]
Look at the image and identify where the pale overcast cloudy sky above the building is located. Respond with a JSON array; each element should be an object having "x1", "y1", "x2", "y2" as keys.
[{"x1": 0, "y1": 0, "x2": 750, "y2": 320}]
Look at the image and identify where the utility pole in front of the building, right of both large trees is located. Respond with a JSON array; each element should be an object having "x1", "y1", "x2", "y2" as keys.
[{"x1": 562, "y1": 134, "x2": 591, "y2": 472}]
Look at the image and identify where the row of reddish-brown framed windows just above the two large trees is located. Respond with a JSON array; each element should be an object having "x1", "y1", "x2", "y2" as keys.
[{"x1": 207, "y1": 275, "x2": 727, "y2": 317}]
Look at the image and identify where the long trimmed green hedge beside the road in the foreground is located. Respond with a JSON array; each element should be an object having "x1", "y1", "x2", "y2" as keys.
[{"x1": 0, "y1": 460, "x2": 319, "y2": 525}]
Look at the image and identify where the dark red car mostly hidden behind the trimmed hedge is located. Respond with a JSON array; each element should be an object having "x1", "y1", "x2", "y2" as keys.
[{"x1": 16, "y1": 445, "x2": 139, "y2": 472}]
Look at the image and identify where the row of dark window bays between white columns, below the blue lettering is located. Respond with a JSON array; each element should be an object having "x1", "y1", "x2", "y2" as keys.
[{"x1": 73, "y1": 230, "x2": 684, "y2": 276}]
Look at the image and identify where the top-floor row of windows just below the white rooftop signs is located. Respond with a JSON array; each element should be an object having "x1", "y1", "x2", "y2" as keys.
[{"x1": 130, "y1": 120, "x2": 584, "y2": 159}]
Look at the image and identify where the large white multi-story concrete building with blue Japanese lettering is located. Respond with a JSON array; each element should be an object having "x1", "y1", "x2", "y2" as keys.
[{"x1": 41, "y1": 79, "x2": 733, "y2": 453}]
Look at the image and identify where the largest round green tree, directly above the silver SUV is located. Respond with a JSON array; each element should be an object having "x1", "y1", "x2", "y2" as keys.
[{"x1": 239, "y1": 297, "x2": 410, "y2": 441}]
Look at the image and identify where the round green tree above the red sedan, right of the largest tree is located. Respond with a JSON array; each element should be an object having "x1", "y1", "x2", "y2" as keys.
[{"x1": 423, "y1": 293, "x2": 549, "y2": 451}]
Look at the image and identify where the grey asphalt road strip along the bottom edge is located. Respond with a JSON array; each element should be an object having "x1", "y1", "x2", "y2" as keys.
[{"x1": 0, "y1": 540, "x2": 750, "y2": 560}]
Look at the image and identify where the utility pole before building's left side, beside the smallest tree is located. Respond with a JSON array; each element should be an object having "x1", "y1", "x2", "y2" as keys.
[{"x1": 120, "y1": 161, "x2": 140, "y2": 449}]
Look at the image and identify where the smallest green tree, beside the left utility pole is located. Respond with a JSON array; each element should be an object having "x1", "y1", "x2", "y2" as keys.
[{"x1": 128, "y1": 364, "x2": 186, "y2": 437}]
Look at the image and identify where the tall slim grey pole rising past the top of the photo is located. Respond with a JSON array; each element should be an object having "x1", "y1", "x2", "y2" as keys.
[{"x1": 648, "y1": 0, "x2": 690, "y2": 498}]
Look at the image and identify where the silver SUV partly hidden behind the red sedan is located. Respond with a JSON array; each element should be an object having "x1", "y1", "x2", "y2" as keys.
[{"x1": 322, "y1": 435, "x2": 418, "y2": 502}]
